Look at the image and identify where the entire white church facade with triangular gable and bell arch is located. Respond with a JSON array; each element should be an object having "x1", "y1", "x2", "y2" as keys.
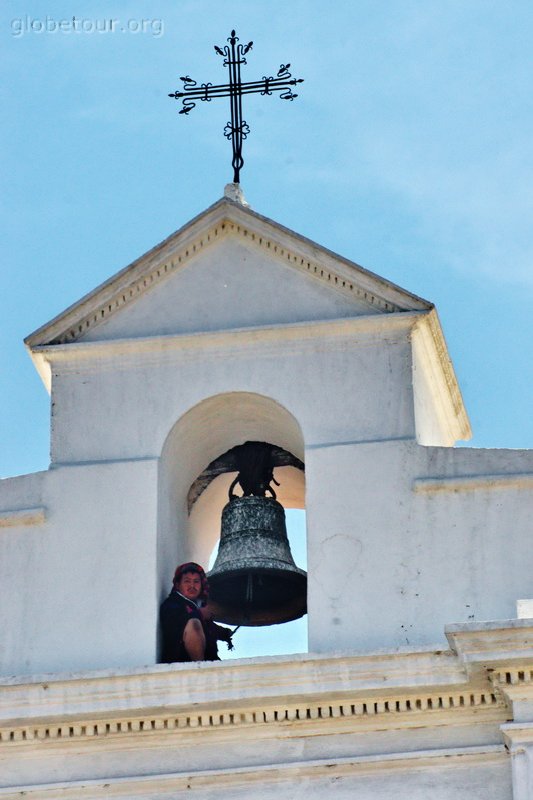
[{"x1": 0, "y1": 194, "x2": 533, "y2": 800}]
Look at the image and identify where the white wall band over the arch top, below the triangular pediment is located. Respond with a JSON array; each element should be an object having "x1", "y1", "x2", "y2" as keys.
[{"x1": 46, "y1": 319, "x2": 415, "y2": 463}]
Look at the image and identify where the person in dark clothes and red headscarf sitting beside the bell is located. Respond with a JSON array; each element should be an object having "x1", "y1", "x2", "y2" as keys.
[{"x1": 159, "y1": 561, "x2": 233, "y2": 664}]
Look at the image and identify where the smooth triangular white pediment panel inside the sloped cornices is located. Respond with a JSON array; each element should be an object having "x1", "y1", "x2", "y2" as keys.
[{"x1": 82, "y1": 238, "x2": 372, "y2": 341}]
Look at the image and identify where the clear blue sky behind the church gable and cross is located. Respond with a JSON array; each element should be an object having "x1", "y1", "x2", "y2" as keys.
[{"x1": 0, "y1": 0, "x2": 533, "y2": 656}]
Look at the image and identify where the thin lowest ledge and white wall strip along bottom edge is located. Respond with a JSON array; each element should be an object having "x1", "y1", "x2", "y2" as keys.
[{"x1": 0, "y1": 748, "x2": 521, "y2": 800}]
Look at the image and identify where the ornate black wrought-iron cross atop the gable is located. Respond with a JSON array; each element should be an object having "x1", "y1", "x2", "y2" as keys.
[{"x1": 169, "y1": 31, "x2": 303, "y2": 183}]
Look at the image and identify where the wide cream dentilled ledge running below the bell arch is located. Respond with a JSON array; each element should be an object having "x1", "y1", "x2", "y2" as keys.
[{"x1": 6, "y1": 619, "x2": 533, "y2": 749}]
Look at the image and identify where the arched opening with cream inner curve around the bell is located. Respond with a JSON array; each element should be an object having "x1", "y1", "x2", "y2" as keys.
[{"x1": 158, "y1": 392, "x2": 307, "y2": 657}]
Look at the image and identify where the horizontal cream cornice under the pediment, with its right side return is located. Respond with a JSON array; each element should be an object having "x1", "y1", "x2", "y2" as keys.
[{"x1": 32, "y1": 310, "x2": 471, "y2": 445}]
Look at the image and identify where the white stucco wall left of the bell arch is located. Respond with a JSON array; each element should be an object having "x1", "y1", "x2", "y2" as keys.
[{"x1": 0, "y1": 461, "x2": 158, "y2": 675}]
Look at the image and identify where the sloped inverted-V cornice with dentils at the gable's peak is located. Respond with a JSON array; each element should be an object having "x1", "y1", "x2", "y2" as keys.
[{"x1": 25, "y1": 198, "x2": 432, "y2": 349}]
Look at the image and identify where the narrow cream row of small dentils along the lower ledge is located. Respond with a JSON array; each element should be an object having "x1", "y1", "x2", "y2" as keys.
[{"x1": 0, "y1": 688, "x2": 502, "y2": 746}]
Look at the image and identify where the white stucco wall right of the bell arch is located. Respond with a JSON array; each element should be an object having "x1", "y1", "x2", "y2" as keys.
[{"x1": 306, "y1": 442, "x2": 533, "y2": 652}]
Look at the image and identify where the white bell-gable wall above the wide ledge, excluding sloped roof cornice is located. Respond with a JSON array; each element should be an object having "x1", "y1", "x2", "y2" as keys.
[{"x1": 0, "y1": 222, "x2": 533, "y2": 673}]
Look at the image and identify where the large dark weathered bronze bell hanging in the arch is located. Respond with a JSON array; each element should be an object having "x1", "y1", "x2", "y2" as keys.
[{"x1": 208, "y1": 442, "x2": 307, "y2": 626}]
